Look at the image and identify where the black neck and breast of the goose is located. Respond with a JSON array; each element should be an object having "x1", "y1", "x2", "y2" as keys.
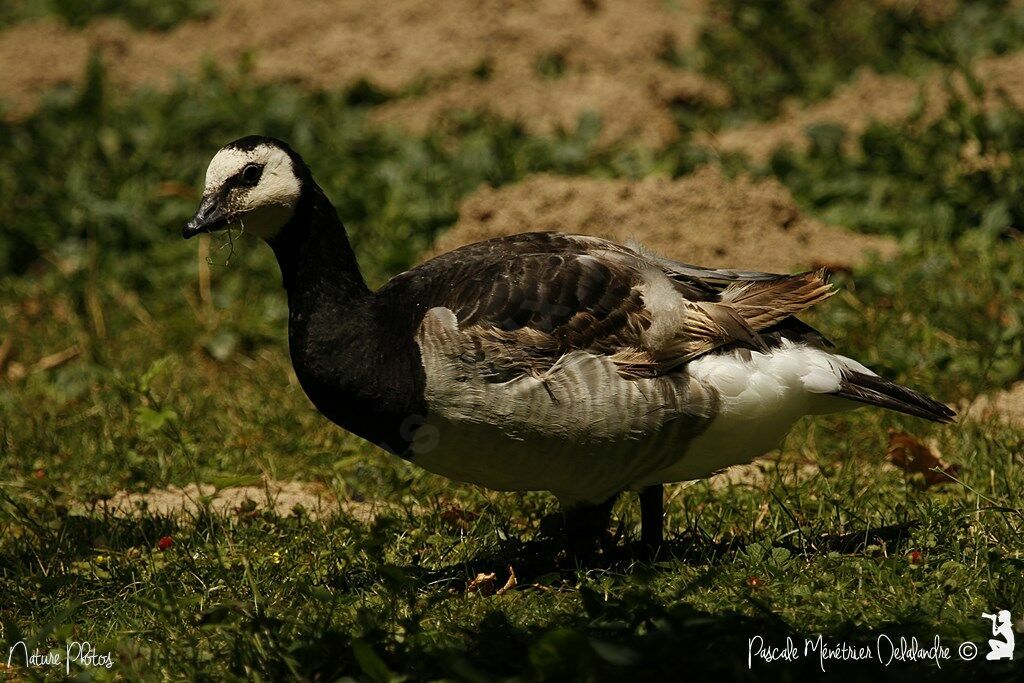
[{"x1": 269, "y1": 178, "x2": 426, "y2": 455}]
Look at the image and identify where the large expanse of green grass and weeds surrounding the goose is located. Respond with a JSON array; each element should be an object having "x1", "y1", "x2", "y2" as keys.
[{"x1": 0, "y1": 24, "x2": 1024, "y2": 681}]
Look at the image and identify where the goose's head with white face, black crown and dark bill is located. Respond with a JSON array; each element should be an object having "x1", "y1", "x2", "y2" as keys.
[{"x1": 181, "y1": 135, "x2": 308, "y2": 241}]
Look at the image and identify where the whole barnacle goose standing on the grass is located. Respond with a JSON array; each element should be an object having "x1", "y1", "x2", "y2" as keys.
[{"x1": 183, "y1": 136, "x2": 954, "y2": 545}]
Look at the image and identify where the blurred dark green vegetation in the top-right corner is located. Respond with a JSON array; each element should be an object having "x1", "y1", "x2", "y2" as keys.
[{"x1": 695, "y1": 0, "x2": 1024, "y2": 118}]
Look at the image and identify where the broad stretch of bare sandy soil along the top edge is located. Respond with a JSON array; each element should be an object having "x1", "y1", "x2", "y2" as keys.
[{"x1": 0, "y1": 0, "x2": 725, "y2": 143}]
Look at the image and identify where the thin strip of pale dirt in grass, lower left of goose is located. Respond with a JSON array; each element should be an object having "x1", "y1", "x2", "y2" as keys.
[{"x1": 78, "y1": 479, "x2": 407, "y2": 521}]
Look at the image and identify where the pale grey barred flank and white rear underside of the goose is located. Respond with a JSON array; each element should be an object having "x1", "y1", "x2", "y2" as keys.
[{"x1": 413, "y1": 308, "x2": 866, "y2": 503}]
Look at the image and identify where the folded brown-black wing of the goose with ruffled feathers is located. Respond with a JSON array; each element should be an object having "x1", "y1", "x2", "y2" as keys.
[{"x1": 409, "y1": 233, "x2": 833, "y2": 381}]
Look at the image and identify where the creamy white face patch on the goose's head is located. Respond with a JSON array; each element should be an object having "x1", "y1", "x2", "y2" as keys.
[{"x1": 204, "y1": 144, "x2": 302, "y2": 240}]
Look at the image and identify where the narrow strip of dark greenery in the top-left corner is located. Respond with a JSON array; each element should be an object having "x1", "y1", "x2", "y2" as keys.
[{"x1": 0, "y1": 0, "x2": 216, "y2": 31}]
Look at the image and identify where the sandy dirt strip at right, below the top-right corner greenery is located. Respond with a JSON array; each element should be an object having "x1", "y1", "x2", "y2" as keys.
[{"x1": 702, "y1": 52, "x2": 1024, "y2": 162}]
